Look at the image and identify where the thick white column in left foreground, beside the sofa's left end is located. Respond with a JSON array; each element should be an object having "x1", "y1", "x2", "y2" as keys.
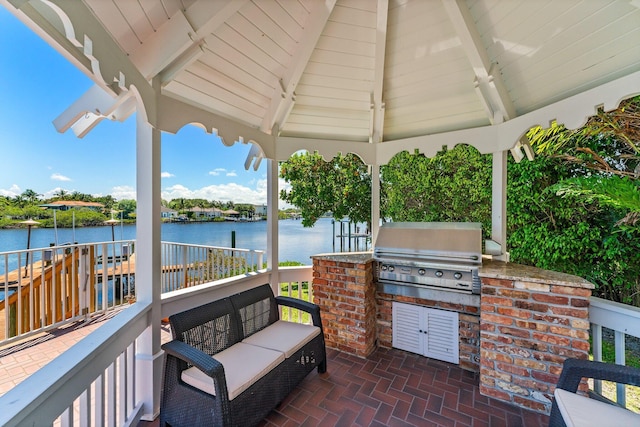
[{"x1": 135, "y1": 105, "x2": 163, "y2": 421}]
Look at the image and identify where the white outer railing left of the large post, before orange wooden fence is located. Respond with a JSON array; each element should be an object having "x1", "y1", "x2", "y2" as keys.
[{"x1": 0, "y1": 241, "x2": 135, "y2": 345}]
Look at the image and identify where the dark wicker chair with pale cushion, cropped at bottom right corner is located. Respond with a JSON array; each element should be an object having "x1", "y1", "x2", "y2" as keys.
[{"x1": 549, "y1": 358, "x2": 640, "y2": 427}]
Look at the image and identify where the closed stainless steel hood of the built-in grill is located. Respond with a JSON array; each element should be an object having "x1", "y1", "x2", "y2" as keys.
[{"x1": 373, "y1": 222, "x2": 482, "y2": 265}]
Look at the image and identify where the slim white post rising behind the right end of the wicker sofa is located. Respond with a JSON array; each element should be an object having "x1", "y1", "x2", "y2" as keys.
[{"x1": 267, "y1": 159, "x2": 280, "y2": 295}]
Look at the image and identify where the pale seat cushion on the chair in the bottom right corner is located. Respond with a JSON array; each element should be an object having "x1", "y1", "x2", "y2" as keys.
[{"x1": 554, "y1": 388, "x2": 640, "y2": 427}]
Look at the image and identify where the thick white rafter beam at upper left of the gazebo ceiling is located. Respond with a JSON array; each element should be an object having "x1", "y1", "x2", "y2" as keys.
[{"x1": 130, "y1": 0, "x2": 248, "y2": 83}]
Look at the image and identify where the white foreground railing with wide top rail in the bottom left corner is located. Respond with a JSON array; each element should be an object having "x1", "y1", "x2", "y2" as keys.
[{"x1": 0, "y1": 303, "x2": 150, "y2": 426}]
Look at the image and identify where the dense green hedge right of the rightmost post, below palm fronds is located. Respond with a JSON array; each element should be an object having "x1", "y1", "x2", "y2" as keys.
[{"x1": 507, "y1": 145, "x2": 640, "y2": 304}]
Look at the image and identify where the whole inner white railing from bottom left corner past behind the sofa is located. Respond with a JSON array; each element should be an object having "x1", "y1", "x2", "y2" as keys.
[{"x1": 0, "y1": 266, "x2": 312, "y2": 426}]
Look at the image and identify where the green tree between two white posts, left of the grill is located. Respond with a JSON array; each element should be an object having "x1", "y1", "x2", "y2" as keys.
[{"x1": 280, "y1": 153, "x2": 371, "y2": 227}]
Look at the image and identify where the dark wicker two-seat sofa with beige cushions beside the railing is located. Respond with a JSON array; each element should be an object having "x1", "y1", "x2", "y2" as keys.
[{"x1": 160, "y1": 285, "x2": 327, "y2": 427}]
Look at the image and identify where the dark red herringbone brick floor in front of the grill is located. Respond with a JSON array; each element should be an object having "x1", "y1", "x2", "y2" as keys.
[{"x1": 255, "y1": 349, "x2": 548, "y2": 427}]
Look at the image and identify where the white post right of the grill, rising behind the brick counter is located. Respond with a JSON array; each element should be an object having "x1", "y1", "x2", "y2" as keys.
[{"x1": 491, "y1": 151, "x2": 509, "y2": 261}]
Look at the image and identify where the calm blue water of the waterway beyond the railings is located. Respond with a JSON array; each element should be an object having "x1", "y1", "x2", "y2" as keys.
[{"x1": 0, "y1": 218, "x2": 370, "y2": 265}]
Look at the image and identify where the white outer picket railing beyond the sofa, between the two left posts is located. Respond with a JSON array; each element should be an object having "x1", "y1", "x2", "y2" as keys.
[{"x1": 162, "y1": 242, "x2": 264, "y2": 293}]
